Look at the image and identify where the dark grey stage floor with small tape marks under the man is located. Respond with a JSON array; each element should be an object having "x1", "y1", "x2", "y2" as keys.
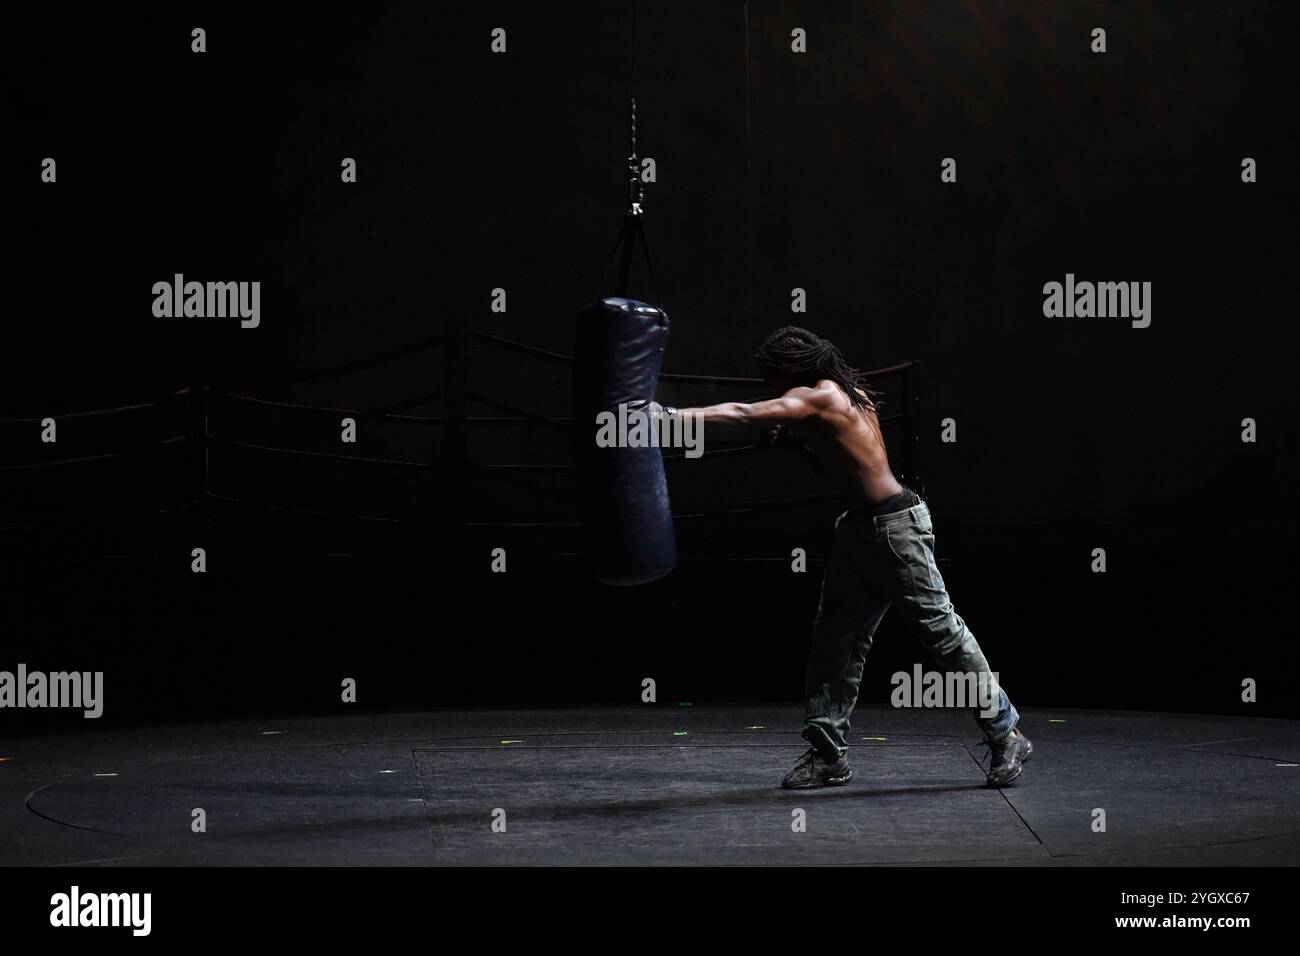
[{"x1": 0, "y1": 705, "x2": 1300, "y2": 865}]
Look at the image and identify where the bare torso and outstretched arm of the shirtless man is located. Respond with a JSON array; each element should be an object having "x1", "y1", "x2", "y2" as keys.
[{"x1": 681, "y1": 378, "x2": 902, "y2": 507}]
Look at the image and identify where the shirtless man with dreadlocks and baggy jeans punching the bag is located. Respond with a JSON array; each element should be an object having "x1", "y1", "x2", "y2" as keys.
[{"x1": 679, "y1": 326, "x2": 1034, "y2": 788}]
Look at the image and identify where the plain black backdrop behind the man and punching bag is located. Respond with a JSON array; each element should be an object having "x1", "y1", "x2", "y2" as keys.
[{"x1": 0, "y1": 0, "x2": 1300, "y2": 722}]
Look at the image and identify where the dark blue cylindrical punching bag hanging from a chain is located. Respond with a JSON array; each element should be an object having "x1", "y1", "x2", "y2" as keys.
[{"x1": 573, "y1": 298, "x2": 677, "y2": 584}]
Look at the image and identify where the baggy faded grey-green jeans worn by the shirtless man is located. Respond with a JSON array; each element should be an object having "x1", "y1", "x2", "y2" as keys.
[{"x1": 803, "y1": 501, "x2": 1019, "y2": 757}]
